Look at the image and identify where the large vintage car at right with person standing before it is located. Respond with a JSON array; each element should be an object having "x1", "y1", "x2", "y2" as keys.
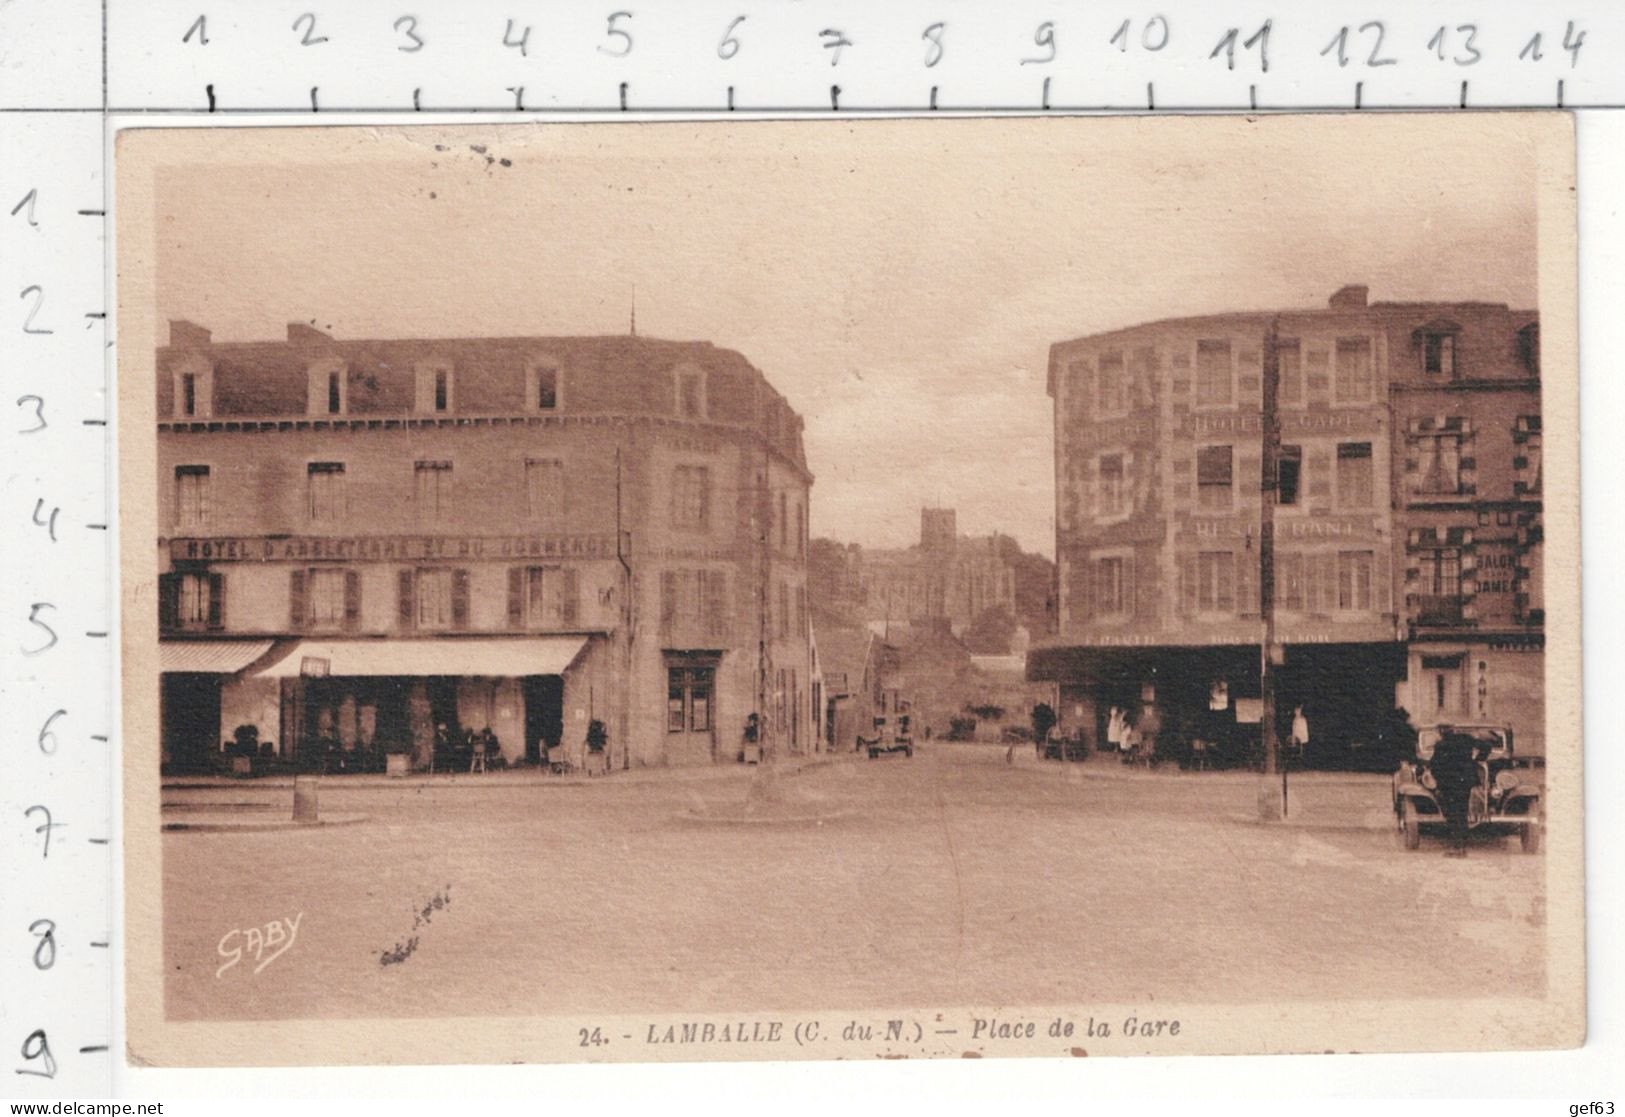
[{"x1": 1393, "y1": 722, "x2": 1545, "y2": 854}]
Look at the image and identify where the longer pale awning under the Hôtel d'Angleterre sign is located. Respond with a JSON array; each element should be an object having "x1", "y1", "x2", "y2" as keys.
[{"x1": 255, "y1": 636, "x2": 587, "y2": 678}]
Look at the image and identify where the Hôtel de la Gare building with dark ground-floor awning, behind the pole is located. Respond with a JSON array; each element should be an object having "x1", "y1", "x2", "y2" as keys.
[{"x1": 1029, "y1": 288, "x2": 1449, "y2": 764}]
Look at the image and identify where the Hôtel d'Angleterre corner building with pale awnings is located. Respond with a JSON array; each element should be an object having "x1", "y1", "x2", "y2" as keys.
[{"x1": 156, "y1": 322, "x2": 817, "y2": 769}]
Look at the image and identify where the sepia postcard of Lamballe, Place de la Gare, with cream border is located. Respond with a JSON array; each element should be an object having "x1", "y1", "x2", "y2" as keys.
[{"x1": 115, "y1": 112, "x2": 1584, "y2": 1067}]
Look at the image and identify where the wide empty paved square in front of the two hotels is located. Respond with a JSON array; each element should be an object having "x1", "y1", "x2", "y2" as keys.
[{"x1": 163, "y1": 745, "x2": 1544, "y2": 1019}]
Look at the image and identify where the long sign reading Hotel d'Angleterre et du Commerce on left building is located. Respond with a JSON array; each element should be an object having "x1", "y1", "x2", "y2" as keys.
[{"x1": 169, "y1": 535, "x2": 614, "y2": 563}]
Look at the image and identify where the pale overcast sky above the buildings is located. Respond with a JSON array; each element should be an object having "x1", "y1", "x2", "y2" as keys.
[{"x1": 146, "y1": 114, "x2": 1536, "y2": 554}]
